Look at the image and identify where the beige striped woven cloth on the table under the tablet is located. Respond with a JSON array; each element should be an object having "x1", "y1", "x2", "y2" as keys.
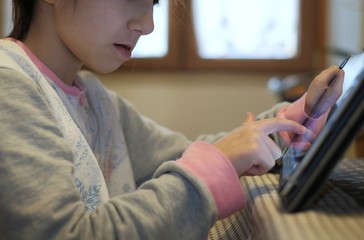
[{"x1": 208, "y1": 159, "x2": 364, "y2": 240}]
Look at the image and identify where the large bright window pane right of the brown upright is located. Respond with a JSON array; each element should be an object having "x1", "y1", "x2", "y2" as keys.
[{"x1": 192, "y1": 0, "x2": 299, "y2": 59}]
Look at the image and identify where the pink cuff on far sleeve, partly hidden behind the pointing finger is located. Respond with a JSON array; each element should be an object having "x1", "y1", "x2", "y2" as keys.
[{"x1": 277, "y1": 94, "x2": 329, "y2": 144}]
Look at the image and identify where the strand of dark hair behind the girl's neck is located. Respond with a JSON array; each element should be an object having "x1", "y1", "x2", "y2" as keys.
[{"x1": 9, "y1": 0, "x2": 36, "y2": 40}]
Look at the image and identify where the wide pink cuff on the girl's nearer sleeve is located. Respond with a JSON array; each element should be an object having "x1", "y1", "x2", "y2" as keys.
[{"x1": 177, "y1": 141, "x2": 246, "y2": 219}]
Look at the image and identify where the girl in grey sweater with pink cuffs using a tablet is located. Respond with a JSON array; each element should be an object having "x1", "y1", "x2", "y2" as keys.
[{"x1": 0, "y1": 0, "x2": 343, "y2": 239}]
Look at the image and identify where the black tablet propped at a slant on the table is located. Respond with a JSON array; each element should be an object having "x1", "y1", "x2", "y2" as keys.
[{"x1": 278, "y1": 53, "x2": 364, "y2": 212}]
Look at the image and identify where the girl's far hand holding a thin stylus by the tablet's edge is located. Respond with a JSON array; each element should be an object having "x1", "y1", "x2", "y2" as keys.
[{"x1": 305, "y1": 66, "x2": 344, "y2": 118}]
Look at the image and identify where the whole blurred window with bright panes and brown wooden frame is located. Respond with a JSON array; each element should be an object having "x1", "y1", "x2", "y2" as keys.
[{"x1": 123, "y1": 0, "x2": 324, "y2": 71}]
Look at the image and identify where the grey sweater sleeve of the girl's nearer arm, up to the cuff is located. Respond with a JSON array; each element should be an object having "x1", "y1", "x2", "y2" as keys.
[{"x1": 0, "y1": 69, "x2": 216, "y2": 239}]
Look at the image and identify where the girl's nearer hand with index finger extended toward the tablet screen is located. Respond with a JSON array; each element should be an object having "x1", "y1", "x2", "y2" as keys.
[{"x1": 214, "y1": 113, "x2": 312, "y2": 176}]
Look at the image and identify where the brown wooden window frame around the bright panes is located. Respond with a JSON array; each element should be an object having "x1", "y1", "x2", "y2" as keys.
[{"x1": 121, "y1": 0, "x2": 326, "y2": 72}]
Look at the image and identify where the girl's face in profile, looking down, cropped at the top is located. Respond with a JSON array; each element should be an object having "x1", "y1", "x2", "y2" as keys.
[{"x1": 47, "y1": 0, "x2": 154, "y2": 73}]
